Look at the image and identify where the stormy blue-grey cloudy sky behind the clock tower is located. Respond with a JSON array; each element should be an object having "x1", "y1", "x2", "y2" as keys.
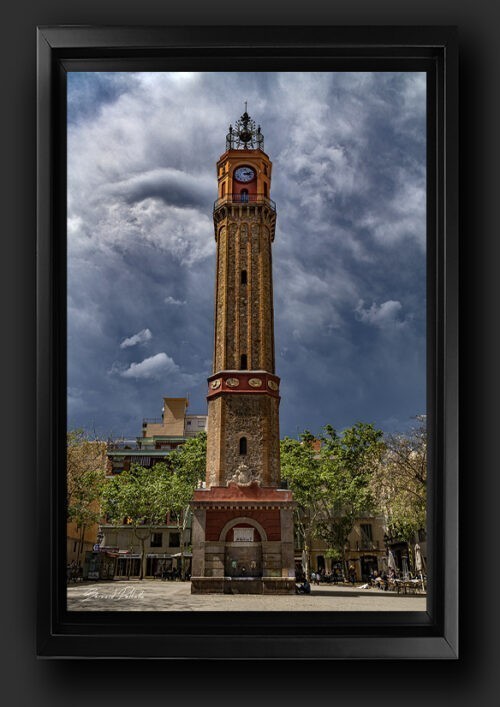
[{"x1": 68, "y1": 72, "x2": 426, "y2": 437}]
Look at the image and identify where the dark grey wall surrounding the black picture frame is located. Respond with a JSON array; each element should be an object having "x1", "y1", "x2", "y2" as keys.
[{"x1": 0, "y1": 0, "x2": 500, "y2": 707}]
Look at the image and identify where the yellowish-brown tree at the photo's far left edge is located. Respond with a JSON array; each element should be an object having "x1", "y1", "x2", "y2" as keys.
[{"x1": 66, "y1": 430, "x2": 106, "y2": 562}]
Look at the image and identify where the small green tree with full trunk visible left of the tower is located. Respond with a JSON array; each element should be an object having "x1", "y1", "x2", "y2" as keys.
[{"x1": 103, "y1": 462, "x2": 172, "y2": 579}]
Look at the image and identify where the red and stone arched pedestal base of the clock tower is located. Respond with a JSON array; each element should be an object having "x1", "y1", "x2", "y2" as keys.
[{"x1": 191, "y1": 483, "x2": 295, "y2": 594}]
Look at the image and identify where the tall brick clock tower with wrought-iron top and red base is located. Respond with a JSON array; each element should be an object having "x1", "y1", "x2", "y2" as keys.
[{"x1": 191, "y1": 105, "x2": 295, "y2": 594}]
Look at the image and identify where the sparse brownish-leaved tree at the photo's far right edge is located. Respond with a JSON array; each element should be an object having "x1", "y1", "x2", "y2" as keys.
[{"x1": 371, "y1": 416, "x2": 427, "y2": 543}]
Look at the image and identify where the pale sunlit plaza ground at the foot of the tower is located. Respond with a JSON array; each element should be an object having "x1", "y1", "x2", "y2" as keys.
[{"x1": 67, "y1": 580, "x2": 426, "y2": 611}]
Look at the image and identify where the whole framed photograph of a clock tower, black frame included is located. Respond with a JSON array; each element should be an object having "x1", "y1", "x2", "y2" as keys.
[{"x1": 37, "y1": 26, "x2": 458, "y2": 660}]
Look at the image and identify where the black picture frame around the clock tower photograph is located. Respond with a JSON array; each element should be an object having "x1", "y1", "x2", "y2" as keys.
[{"x1": 37, "y1": 26, "x2": 459, "y2": 659}]
